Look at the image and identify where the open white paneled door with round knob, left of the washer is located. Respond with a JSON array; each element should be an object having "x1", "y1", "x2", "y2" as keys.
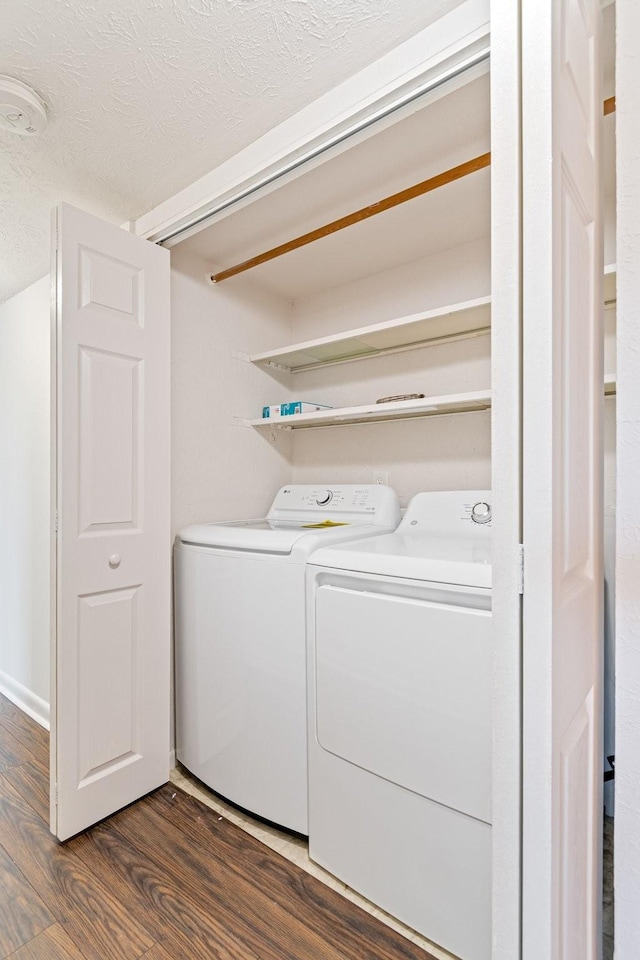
[{"x1": 51, "y1": 204, "x2": 171, "y2": 840}]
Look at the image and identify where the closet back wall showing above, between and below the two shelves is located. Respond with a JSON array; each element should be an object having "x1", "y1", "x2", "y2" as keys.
[{"x1": 293, "y1": 239, "x2": 491, "y2": 506}]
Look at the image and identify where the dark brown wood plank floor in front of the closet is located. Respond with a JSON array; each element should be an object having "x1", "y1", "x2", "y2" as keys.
[{"x1": 0, "y1": 695, "x2": 430, "y2": 960}]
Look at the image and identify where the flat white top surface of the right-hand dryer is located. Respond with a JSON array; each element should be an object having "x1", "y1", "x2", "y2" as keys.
[{"x1": 311, "y1": 532, "x2": 491, "y2": 588}]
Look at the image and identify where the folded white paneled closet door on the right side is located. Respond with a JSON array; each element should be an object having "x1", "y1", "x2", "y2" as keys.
[{"x1": 522, "y1": 0, "x2": 603, "y2": 960}]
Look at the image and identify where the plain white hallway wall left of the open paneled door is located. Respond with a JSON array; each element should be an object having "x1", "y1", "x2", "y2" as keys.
[{"x1": 0, "y1": 277, "x2": 50, "y2": 720}]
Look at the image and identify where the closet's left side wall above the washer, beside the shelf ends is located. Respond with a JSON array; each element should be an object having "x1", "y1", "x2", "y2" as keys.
[{"x1": 171, "y1": 247, "x2": 291, "y2": 533}]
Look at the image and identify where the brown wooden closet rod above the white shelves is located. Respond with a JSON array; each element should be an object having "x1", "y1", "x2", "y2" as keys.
[{"x1": 209, "y1": 97, "x2": 616, "y2": 283}]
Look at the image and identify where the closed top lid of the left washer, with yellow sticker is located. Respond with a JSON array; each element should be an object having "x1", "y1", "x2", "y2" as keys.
[{"x1": 178, "y1": 517, "x2": 371, "y2": 554}]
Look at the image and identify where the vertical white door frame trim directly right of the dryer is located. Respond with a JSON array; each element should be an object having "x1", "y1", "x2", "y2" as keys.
[{"x1": 491, "y1": 0, "x2": 522, "y2": 960}]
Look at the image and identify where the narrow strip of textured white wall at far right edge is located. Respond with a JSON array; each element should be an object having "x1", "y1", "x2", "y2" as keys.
[{"x1": 615, "y1": 0, "x2": 640, "y2": 960}]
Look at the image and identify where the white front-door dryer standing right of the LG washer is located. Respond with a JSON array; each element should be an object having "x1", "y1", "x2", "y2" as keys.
[{"x1": 307, "y1": 490, "x2": 492, "y2": 960}]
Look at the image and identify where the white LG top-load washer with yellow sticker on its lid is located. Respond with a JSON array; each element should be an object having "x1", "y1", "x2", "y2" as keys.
[{"x1": 174, "y1": 484, "x2": 400, "y2": 834}]
